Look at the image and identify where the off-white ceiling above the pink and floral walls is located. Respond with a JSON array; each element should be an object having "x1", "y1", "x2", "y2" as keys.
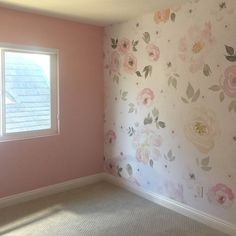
[{"x1": 0, "y1": 0, "x2": 187, "y2": 26}]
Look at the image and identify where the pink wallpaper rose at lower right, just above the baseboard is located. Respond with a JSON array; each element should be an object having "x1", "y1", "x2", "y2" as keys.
[{"x1": 208, "y1": 184, "x2": 235, "y2": 207}]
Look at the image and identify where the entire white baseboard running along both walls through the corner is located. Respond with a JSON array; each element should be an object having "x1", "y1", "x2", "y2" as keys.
[{"x1": 0, "y1": 173, "x2": 236, "y2": 236}]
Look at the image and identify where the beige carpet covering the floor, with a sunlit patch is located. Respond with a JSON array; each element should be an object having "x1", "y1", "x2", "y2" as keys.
[{"x1": 0, "y1": 183, "x2": 229, "y2": 236}]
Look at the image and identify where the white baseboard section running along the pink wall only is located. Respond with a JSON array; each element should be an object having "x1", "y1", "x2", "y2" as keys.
[{"x1": 0, "y1": 173, "x2": 104, "y2": 208}]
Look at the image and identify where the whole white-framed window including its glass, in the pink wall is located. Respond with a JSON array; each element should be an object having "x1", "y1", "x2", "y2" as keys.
[{"x1": 0, "y1": 44, "x2": 58, "y2": 141}]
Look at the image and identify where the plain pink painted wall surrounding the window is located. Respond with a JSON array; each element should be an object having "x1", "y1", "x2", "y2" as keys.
[{"x1": 0, "y1": 8, "x2": 103, "y2": 197}]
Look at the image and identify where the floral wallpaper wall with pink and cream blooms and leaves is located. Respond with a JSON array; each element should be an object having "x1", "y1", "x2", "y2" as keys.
[{"x1": 104, "y1": 0, "x2": 236, "y2": 224}]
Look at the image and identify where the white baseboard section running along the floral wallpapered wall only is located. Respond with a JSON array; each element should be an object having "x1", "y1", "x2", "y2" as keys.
[{"x1": 104, "y1": 174, "x2": 236, "y2": 236}]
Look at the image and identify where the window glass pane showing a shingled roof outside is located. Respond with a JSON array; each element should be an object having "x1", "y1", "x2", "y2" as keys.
[{"x1": 5, "y1": 52, "x2": 51, "y2": 133}]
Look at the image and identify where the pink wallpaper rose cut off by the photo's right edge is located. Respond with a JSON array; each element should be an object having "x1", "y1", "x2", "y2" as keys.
[{"x1": 224, "y1": 65, "x2": 236, "y2": 97}]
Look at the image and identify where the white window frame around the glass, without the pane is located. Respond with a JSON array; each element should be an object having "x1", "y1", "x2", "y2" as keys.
[{"x1": 0, "y1": 43, "x2": 60, "y2": 142}]
